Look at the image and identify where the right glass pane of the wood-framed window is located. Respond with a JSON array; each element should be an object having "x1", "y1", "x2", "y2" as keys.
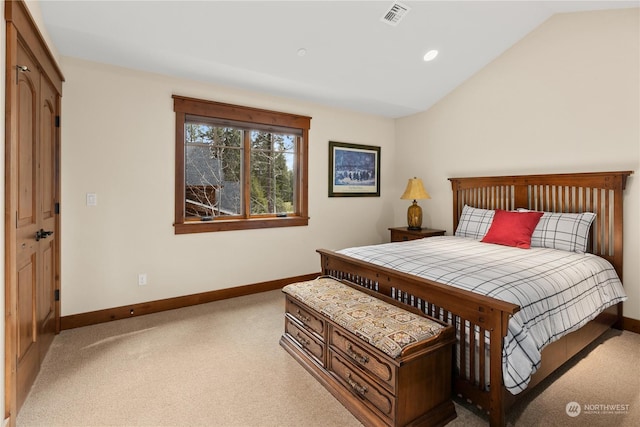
[{"x1": 250, "y1": 131, "x2": 297, "y2": 215}]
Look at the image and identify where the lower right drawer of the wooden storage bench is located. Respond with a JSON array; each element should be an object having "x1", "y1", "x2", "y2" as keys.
[{"x1": 327, "y1": 349, "x2": 396, "y2": 425}]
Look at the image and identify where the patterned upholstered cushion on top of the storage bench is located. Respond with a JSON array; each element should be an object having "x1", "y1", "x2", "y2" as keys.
[{"x1": 282, "y1": 277, "x2": 444, "y2": 358}]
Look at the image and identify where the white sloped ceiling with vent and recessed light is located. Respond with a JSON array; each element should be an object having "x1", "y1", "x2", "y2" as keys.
[{"x1": 40, "y1": 0, "x2": 640, "y2": 117}]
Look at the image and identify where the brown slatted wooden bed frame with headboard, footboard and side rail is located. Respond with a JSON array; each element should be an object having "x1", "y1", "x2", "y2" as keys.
[{"x1": 318, "y1": 171, "x2": 632, "y2": 426}]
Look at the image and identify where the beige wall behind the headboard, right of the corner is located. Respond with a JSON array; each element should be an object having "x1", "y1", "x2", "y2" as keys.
[{"x1": 396, "y1": 9, "x2": 640, "y2": 319}]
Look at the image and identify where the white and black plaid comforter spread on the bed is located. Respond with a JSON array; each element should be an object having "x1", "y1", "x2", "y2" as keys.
[{"x1": 337, "y1": 236, "x2": 627, "y2": 394}]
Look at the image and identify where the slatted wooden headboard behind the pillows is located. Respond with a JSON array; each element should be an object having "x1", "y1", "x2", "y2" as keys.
[{"x1": 449, "y1": 171, "x2": 633, "y2": 279}]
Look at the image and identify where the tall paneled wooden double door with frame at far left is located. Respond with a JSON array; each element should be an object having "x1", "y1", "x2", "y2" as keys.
[{"x1": 4, "y1": 1, "x2": 64, "y2": 426}]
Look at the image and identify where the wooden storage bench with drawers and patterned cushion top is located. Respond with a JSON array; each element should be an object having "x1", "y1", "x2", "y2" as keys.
[{"x1": 280, "y1": 277, "x2": 456, "y2": 426}]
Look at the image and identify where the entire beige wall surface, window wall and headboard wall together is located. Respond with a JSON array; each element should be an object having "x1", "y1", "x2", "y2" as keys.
[{"x1": 62, "y1": 5, "x2": 640, "y2": 319}]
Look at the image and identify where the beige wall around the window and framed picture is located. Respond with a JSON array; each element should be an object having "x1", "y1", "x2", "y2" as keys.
[{"x1": 61, "y1": 58, "x2": 395, "y2": 316}]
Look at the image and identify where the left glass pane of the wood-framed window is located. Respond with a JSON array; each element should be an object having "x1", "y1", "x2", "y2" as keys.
[{"x1": 185, "y1": 123, "x2": 243, "y2": 217}]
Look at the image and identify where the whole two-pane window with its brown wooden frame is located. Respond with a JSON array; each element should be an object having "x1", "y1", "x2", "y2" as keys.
[{"x1": 173, "y1": 95, "x2": 311, "y2": 234}]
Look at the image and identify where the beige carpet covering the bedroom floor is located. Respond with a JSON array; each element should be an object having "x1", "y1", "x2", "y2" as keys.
[{"x1": 17, "y1": 291, "x2": 640, "y2": 427}]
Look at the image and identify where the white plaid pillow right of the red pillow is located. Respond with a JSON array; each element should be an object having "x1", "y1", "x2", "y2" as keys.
[{"x1": 531, "y1": 212, "x2": 596, "y2": 253}]
